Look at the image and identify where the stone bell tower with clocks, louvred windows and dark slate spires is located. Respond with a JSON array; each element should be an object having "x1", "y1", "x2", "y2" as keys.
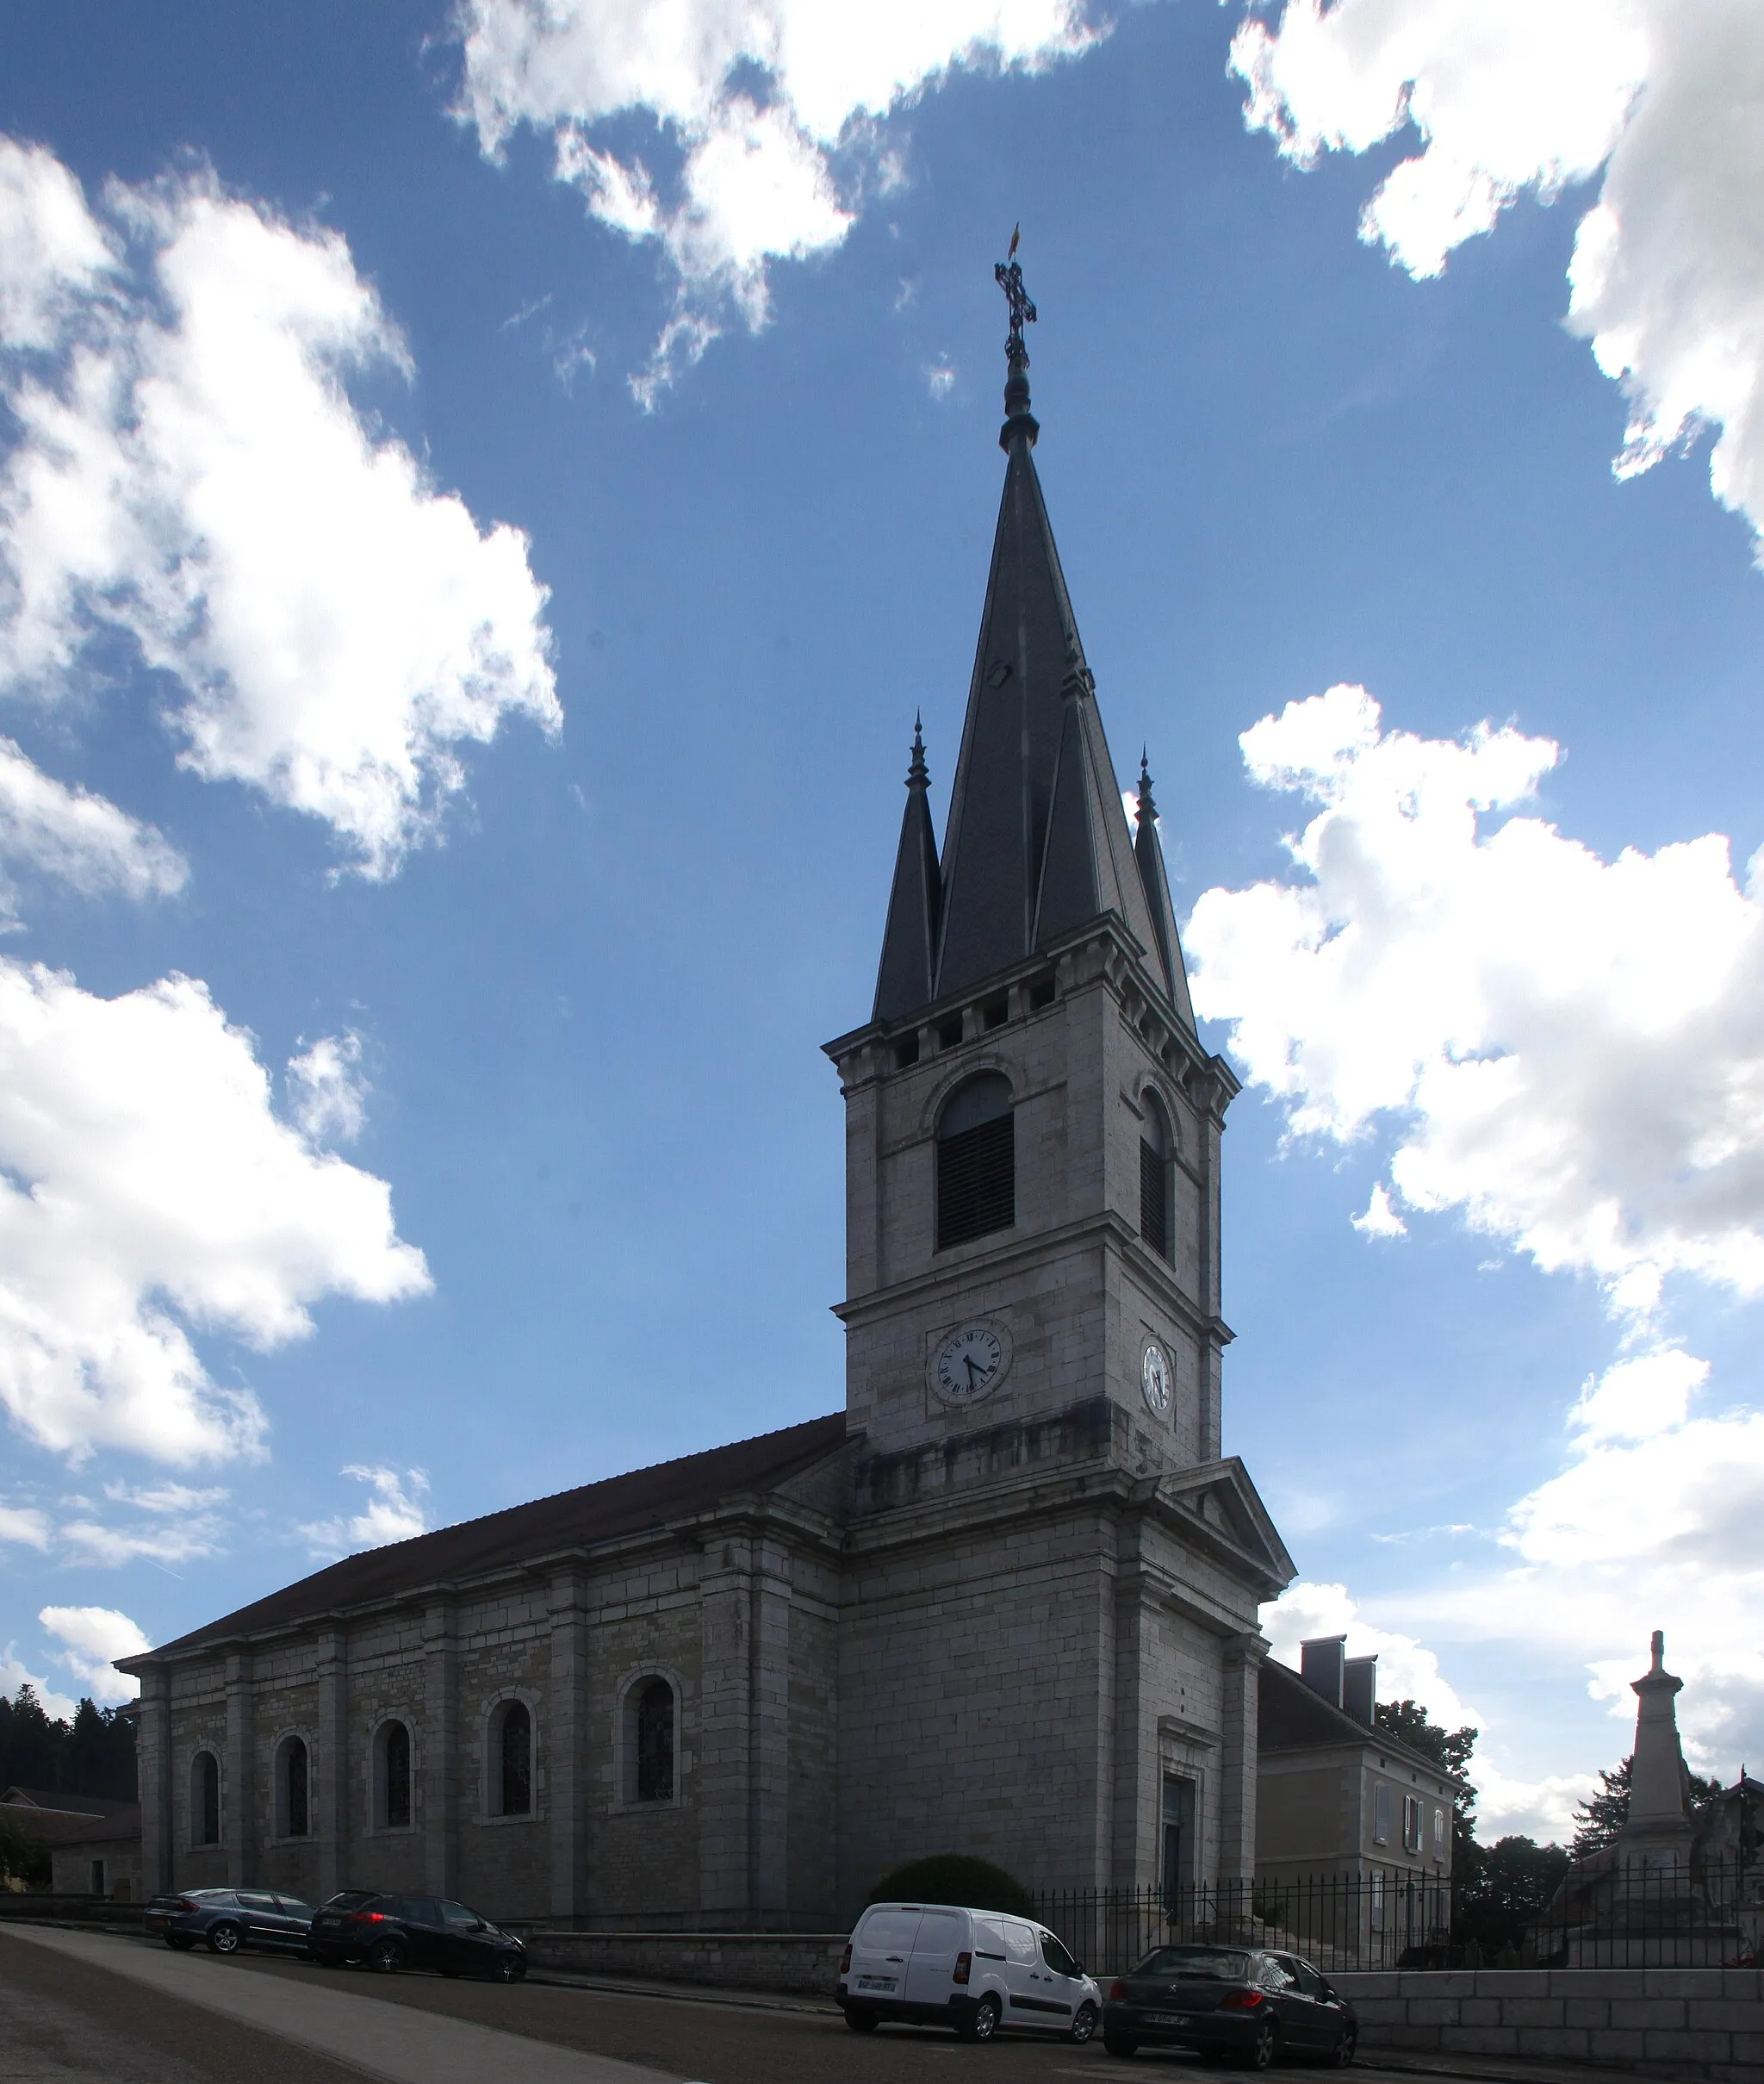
[{"x1": 827, "y1": 258, "x2": 1237, "y2": 1488}]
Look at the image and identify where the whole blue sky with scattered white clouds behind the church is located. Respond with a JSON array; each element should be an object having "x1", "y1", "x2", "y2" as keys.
[{"x1": 0, "y1": 0, "x2": 1764, "y2": 1830}]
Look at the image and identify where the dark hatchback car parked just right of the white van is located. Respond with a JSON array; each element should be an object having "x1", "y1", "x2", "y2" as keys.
[{"x1": 1102, "y1": 1946, "x2": 1360, "y2": 2069}]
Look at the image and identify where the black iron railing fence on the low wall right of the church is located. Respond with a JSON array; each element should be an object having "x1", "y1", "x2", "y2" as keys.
[{"x1": 1035, "y1": 1855, "x2": 1764, "y2": 1975}]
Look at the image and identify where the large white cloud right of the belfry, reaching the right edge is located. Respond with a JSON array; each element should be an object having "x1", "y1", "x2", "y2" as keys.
[{"x1": 1183, "y1": 687, "x2": 1764, "y2": 1315}]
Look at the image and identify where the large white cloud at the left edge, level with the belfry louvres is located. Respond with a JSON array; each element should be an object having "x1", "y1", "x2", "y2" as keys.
[{"x1": 0, "y1": 961, "x2": 429, "y2": 1466}]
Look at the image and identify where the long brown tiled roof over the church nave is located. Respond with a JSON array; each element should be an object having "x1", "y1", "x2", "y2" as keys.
[{"x1": 136, "y1": 1411, "x2": 846, "y2": 1671}]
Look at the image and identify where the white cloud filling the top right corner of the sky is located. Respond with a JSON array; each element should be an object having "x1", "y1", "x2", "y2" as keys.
[{"x1": 1233, "y1": 0, "x2": 1764, "y2": 554}]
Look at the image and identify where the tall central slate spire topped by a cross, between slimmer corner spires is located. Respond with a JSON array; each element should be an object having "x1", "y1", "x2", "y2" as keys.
[{"x1": 933, "y1": 242, "x2": 1187, "y2": 1009}]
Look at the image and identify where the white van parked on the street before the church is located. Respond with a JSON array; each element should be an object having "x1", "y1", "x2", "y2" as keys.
[{"x1": 839, "y1": 1903, "x2": 1102, "y2": 2043}]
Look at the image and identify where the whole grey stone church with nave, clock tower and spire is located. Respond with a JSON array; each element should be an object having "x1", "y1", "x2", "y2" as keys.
[{"x1": 123, "y1": 263, "x2": 1294, "y2": 1930}]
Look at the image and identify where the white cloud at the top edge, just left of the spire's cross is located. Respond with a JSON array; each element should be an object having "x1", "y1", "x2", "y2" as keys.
[{"x1": 457, "y1": 0, "x2": 1104, "y2": 404}]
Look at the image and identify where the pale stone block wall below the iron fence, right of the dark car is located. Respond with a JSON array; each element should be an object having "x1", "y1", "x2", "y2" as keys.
[{"x1": 1331, "y1": 1968, "x2": 1764, "y2": 2084}]
